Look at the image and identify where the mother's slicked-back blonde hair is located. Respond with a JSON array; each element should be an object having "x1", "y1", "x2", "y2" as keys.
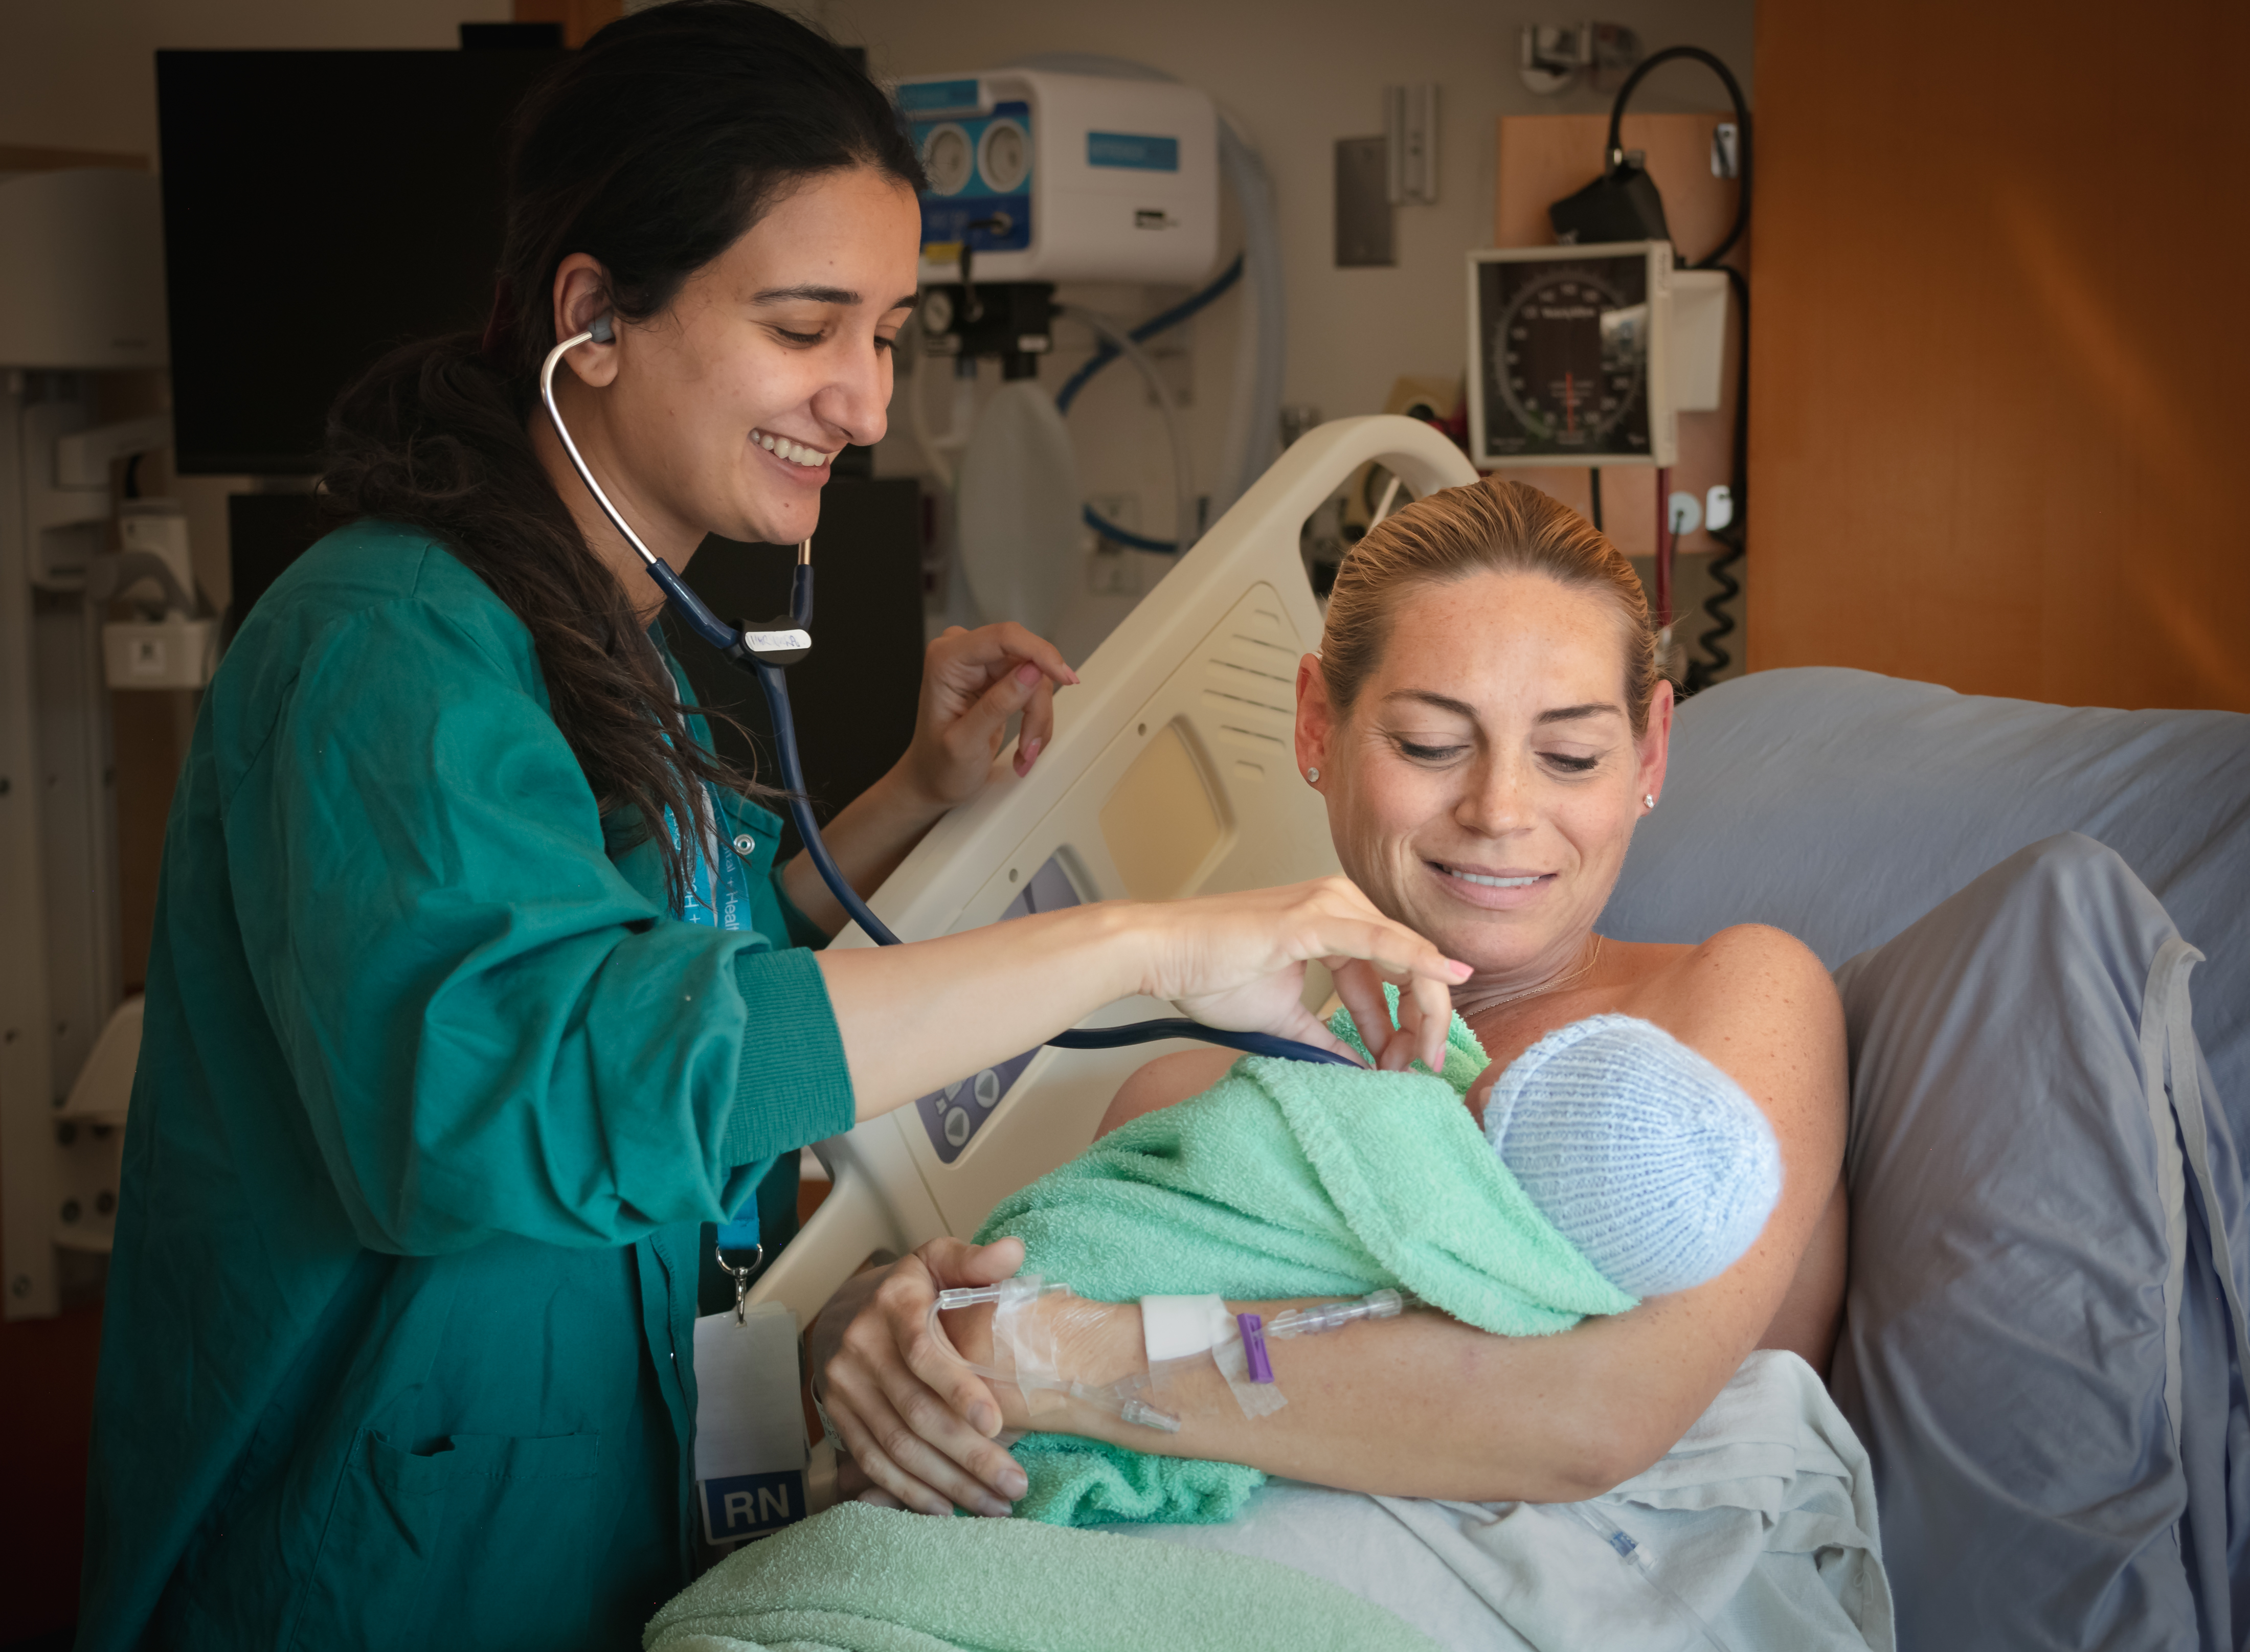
[{"x1": 1321, "y1": 477, "x2": 1656, "y2": 734}]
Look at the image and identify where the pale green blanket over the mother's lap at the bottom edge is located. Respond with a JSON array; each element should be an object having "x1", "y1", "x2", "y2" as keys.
[{"x1": 641, "y1": 1503, "x2": 1435, "y2": 1652}]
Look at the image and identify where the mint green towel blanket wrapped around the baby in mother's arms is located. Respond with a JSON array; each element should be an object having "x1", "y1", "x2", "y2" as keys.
[{"x1": 977, "y1": 994, "x2": 1633, "y2": 1526}]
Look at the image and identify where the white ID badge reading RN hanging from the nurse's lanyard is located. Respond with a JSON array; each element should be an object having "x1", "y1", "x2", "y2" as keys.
[{"x1": 695, "y1": 1303, "x2": 808, "y2": 1544}]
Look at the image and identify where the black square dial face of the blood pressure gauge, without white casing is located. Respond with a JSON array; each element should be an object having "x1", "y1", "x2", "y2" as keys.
[{"x1": 1476, "y1": 247, "x2": 1649, "y2": 464}]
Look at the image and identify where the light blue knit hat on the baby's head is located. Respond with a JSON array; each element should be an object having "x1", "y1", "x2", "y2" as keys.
[{"x1": 1485, "y1": 1015, "x2": 1782, "y2": 1296}]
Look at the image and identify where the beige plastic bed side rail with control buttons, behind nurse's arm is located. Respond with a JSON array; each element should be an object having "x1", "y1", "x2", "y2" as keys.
[{"x1": 752, "y1": 416, "x2": 1476, "y2": 1323}]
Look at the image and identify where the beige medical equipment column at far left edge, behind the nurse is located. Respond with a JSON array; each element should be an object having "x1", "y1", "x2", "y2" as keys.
[{"x1": 0, "y1": 169, "x2": 177, "y2": 1319}]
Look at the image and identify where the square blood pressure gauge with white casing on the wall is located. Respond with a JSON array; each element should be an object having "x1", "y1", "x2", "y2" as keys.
[{"x1": 1469, "y1": 241, "x2": 1678, "y2": 468}]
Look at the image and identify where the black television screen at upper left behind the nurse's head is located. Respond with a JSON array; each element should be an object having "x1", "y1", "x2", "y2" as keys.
[{"x1": 155, "y1": 52, "x2": 562, "y2": 475}]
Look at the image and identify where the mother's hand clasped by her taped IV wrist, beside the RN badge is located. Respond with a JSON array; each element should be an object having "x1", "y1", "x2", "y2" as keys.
[{"x1": 805, "y1": 1238, "x2": 1024, "y2": 1514}]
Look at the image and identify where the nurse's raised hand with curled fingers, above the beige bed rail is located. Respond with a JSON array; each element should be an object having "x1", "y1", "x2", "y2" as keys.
[{"x1": 898, "y1": 621, "x2": 1078, "y2": 812}]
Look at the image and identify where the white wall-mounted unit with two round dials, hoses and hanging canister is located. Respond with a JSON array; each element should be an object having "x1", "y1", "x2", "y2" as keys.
[{"x1": 898, "y1": 56, "x2": 1282, "y2": 662}]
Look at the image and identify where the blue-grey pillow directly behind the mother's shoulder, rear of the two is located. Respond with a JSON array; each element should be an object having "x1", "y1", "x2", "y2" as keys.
[{"x1": 1600, "y1": 666, "x2": 2250, "y2": 1141}]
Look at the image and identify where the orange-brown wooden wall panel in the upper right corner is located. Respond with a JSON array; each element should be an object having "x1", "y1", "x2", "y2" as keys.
[{"x1": 1748, "y1": 0, "x2": 2250, "y2": 711}]
